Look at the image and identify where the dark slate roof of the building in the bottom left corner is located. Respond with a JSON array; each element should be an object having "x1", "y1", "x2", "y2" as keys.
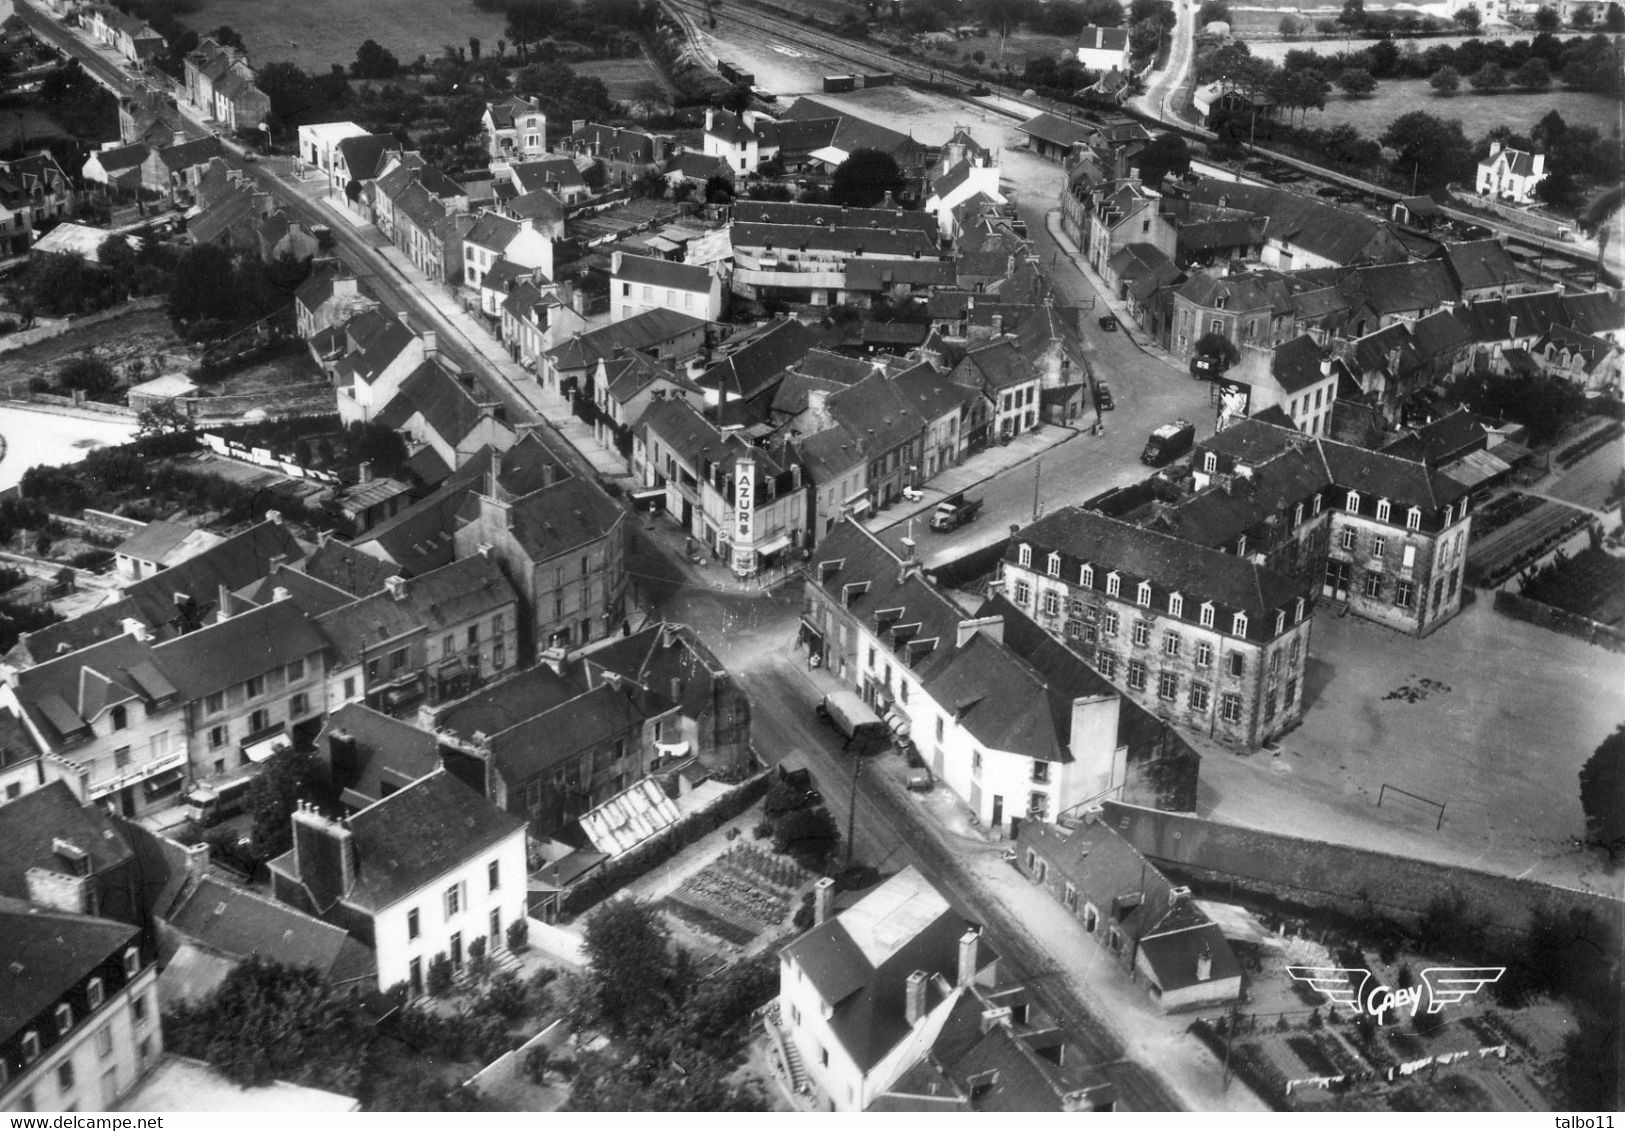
[{"x1": 0, "y1": 897, "x2": 138, "y2": 1043}]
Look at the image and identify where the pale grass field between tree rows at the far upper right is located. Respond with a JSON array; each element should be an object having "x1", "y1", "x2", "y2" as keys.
[{"x1": 1305, "y1": 78, "x2": 1620, "y2": 140}]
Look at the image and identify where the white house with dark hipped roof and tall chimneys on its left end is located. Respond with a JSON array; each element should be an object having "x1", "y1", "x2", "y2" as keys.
[{"x1": 270, "y1": 769, "x2": 527, "y2": 995}]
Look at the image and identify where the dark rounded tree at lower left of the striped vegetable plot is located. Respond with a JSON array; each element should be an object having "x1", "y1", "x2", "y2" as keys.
[{"x1": 582, "y1": 899, "x2": 683, "y2": 1032}]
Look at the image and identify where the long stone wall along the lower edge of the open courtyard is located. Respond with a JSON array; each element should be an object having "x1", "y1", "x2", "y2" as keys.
[{"x1": 1103, "y1": 801, "x2": 1625, "y2": 952}]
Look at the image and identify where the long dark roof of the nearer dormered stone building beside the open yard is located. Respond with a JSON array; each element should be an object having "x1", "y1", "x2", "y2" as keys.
[{"x1": 1006, "y1": 507, "x2": 1308, "y2": 640}]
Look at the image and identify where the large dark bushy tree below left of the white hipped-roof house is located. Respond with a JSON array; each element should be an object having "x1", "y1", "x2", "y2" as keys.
[{"x1": 164, "y1": 957, "x2": 369, "y2": 1095}]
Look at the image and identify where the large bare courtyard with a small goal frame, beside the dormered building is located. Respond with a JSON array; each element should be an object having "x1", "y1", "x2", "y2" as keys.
[{"x1": 1196, "y1": 595, "x2": 1625, "y2": 894}]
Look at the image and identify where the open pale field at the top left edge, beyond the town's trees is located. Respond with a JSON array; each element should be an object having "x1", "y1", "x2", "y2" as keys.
[{"x1": 138, "y1": 0, "x2": 504, "y2": 72}]
